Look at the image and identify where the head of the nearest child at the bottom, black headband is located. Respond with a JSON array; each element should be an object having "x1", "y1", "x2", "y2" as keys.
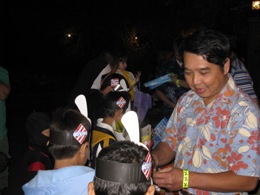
[{"x1": 89, "y1": 141, "x2": 155, "y2": 195}]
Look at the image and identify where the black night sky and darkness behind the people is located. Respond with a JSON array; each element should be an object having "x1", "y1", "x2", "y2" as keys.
[{"x1": 1, "y1": 0, "x2": 260, "y2": 194}]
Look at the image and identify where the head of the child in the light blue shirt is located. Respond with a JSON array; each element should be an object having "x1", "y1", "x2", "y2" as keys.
[{"x1": 48, "y1": 109, "x2": 91, "y2": 165}]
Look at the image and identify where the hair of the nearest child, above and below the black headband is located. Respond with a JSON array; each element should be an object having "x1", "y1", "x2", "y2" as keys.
[{"x1": 94, "y1": 140, "x2": 151, "y2": 195}]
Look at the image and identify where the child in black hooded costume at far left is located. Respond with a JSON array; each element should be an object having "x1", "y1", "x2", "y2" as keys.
[{"x1": 21, "y1": 112, "x2": 54, "y2": 184}]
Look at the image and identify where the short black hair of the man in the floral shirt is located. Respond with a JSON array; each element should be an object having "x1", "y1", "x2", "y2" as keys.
[{"x1": 183, "y1": 29, "x2": 230, "y2": 68}]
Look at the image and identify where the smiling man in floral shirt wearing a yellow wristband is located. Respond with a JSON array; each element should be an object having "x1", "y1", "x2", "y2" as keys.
[{"x1": 152, "y1": 30, "x2": 260, "y2": 194}]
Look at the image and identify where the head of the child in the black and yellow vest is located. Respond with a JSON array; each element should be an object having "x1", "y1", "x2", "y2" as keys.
[{"x1": 104, "y1": 91, "x2": 130, "y2": 121}]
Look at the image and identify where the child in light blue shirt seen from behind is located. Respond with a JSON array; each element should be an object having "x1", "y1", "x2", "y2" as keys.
[{"x1": 22, "y1": 109, "x2": 95, "y2": 195}]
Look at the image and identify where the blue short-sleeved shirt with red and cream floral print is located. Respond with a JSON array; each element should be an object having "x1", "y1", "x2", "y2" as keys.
[{"x1": 162, "y1": 76, "x2": 260, "y2": 194}]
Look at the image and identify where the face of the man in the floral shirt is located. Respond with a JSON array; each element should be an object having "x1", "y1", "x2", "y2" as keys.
[{"x1": 184, "y1": 52, "x2": 229, "y2": 105}]
